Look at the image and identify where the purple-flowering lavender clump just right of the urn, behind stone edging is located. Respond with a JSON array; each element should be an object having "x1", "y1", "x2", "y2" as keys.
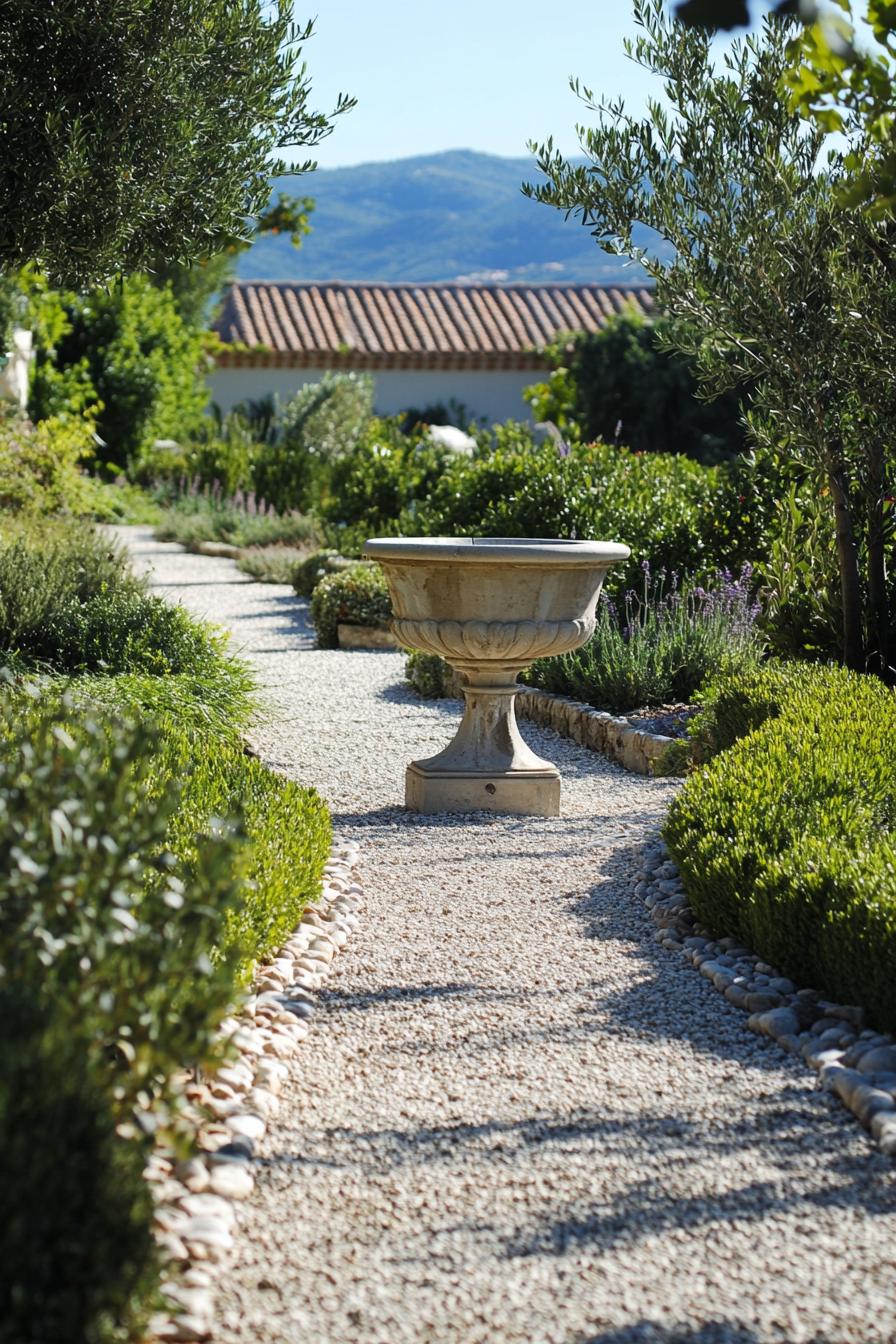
[{"x1": 524, "y1": 560, "x2": 764, "y2": 714}]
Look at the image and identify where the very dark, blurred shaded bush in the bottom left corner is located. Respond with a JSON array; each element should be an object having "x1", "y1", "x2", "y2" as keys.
[{"x1": 0, "y1": 986, "x2": 159, "y2": 1344}]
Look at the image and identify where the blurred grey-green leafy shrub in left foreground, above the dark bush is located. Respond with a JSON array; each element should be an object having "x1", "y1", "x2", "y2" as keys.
[{"x1": 0, "y1": 684, "x2": 247, "y2": 1124}]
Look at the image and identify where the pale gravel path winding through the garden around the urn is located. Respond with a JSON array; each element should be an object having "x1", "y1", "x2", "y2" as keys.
[{"x1": 120, "y1": 528, "x2": 896, "y2": 1344}]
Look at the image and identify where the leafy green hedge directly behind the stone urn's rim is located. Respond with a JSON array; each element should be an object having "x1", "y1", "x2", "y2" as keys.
[{"x1": 318, "y1": 422, "x2": 748, "y2": 587}]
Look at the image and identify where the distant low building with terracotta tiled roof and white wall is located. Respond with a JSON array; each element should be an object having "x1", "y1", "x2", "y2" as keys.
[{"x1": 210, "y1": 281, "x2": 653, "y2": 423}]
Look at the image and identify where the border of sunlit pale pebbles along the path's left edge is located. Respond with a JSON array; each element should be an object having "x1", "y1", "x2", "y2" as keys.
[{"x1": 145, "y1": 841, "x2": 363, "y2": 1341}]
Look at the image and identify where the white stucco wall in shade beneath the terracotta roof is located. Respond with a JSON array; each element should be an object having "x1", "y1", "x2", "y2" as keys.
[{"x1": 208, "y1": 368, "x2": 545, "y2": 425}]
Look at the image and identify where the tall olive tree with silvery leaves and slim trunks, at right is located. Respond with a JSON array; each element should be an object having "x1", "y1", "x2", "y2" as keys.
[{"x1": 525, "y1": 0, "x2": 896, "y2": 671}]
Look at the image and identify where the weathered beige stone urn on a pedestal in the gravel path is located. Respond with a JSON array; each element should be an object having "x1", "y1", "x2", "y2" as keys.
[{"x1": 364, "y1": 536, "x2": 630, "y2": 817}]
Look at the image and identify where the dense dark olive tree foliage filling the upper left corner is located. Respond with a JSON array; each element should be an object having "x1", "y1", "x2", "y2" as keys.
[{"x1": 0, "y1": 0, "x2": 353, "y2": 289}]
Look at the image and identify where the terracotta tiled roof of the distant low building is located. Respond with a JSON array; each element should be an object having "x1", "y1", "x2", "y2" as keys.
[{"x1": 215, "y1": 281, "x2": 653, "y2": 368}]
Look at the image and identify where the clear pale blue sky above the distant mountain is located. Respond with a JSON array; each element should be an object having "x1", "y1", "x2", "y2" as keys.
[{"x1": 297, "y1": 0, "x2": 658, "y2": 168}]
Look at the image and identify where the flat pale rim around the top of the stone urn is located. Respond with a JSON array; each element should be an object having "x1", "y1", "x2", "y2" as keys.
[{"x1": 364, "y1": 536, "x2": 631, "y2": 567}]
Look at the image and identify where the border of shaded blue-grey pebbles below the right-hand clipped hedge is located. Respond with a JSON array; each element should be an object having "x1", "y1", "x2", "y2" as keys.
[{"x1": 634, "y1": 837, "x2": 896, "y2": 1157}]
